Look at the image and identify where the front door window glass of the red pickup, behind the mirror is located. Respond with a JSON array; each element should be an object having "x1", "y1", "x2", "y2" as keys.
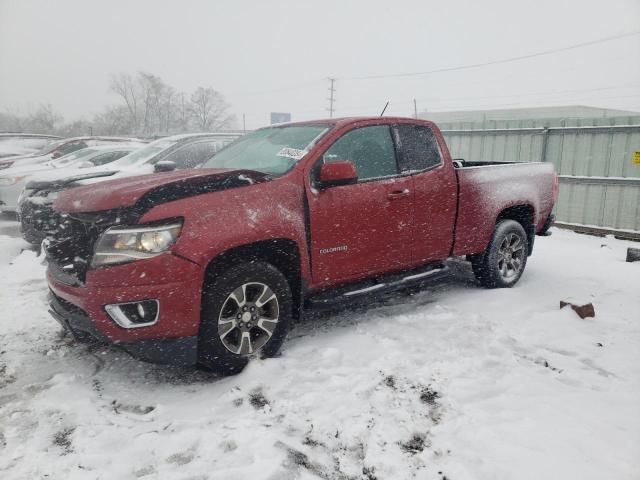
[{"x1": 323, "y1": 125, "x2": 398, "y2": 180}]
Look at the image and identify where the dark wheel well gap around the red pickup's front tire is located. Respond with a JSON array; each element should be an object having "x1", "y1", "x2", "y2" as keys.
[{"x1": 204, "y1": 238, "x2": 303, "y2": 319}]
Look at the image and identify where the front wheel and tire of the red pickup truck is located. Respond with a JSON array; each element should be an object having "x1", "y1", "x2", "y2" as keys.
[{"x1": 198, "y1": 262, "x2": 293, "y2": 375}]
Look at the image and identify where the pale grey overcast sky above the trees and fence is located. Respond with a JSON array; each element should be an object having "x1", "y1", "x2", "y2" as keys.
[{"x1": 0, "y1": 0, "x2": 640, "y2": 128}]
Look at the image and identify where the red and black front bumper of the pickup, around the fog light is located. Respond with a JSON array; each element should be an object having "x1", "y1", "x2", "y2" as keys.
[{"x1": 47, "y1": 254, "x2": 204, "y2": 366}]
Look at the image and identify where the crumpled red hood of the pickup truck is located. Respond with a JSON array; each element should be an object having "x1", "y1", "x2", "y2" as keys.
[{"x1": 54, "y1": 168, "x2": 271, "y2": 213}]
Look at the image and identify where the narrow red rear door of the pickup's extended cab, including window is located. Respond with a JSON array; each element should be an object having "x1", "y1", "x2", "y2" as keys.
[{"x1": 394, "y1": 124, "x2": 458, "y2": 263}]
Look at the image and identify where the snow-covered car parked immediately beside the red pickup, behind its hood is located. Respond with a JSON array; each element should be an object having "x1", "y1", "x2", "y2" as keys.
[{"x1": 18, "y1": 133, "x2": 238, "y2": 243}]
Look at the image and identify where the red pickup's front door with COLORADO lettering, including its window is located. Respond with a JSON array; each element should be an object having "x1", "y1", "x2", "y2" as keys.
[{"x1": 307, "y1": 125, "x2": 413, "y2": 284}]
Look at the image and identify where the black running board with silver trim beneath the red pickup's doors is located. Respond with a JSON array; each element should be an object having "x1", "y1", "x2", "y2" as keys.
[{"x1": 305, "y1": 265, "x2": 449, "y2": 310}]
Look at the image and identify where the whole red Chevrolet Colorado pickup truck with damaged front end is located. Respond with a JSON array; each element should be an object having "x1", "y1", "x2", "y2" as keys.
[{"x1": 45, "y1": 118, "x2": 558, "y2": 373}]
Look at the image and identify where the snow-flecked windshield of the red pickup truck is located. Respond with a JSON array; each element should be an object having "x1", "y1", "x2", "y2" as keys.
[{"x1": 202, "y1": 125, "x2": 328, "y2": 176}]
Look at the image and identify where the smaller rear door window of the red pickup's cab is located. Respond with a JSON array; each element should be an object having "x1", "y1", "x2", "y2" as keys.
[{"x1": 396, "y1": 125, "x2": 442, "y2": 172}]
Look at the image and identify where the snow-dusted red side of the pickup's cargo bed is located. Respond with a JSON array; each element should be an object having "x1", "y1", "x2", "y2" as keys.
[{"x1": 453, "y1": 160, "x2": 554, "y2": 256}]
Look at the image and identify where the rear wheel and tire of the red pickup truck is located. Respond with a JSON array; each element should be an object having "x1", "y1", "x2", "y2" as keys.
[{"x1": 471, "y1": 220, "x2": 529, "y2": 288}]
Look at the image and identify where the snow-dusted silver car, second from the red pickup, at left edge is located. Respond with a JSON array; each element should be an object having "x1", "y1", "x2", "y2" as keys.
[{"x1": 0, "y1": 143, "x2": 144, "y2": 212}]
